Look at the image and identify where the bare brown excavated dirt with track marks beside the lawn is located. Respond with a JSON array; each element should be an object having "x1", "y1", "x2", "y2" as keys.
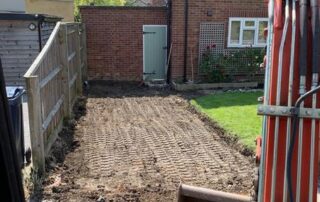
[{"x1": 32, "y1": 82, "x2": 254, "y2": 202}]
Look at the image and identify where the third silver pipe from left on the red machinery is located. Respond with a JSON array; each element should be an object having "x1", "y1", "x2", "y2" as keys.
[{"x1": 283, "y1": 1, "x2": 297, "y2": 202}]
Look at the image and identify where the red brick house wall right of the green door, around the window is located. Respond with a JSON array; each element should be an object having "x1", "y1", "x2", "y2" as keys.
[{"x1": 171, "y1": 0, "x2": 268, "y2": 80}]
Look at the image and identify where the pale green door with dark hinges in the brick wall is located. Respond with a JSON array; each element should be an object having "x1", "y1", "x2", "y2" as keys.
[{"x1": 143, "y1": 25, "x2": 167, "y2": 81}]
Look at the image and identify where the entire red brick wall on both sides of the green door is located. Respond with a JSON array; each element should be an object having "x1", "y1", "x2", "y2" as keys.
[{"x1": 80, "y1": 0, "x2": 268, "y2": 80}]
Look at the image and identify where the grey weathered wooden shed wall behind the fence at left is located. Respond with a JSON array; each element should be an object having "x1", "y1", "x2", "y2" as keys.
[{"x1": 0, "y1": 13, "x2": 60, "y2": 86}]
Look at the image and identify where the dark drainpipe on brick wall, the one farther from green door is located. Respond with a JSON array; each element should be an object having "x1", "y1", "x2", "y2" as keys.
[{"x1": 183, "y1": 0, "x2": 189, "y2": 82}]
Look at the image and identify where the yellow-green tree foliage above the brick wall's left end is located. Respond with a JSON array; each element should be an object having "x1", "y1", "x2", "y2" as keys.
[{"x1": 74, "y1": 0, "x2": 126, "y2": 21}]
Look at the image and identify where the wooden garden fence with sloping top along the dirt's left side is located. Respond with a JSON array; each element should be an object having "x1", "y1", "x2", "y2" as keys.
[{"x1": 24, "y1": 22, "x2": 86, "y2": 173}]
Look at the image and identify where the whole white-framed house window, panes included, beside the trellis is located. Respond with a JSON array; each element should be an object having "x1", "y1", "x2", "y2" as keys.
[{"x1": 228, "y1": 18, "x2": 268, "y2": 48}]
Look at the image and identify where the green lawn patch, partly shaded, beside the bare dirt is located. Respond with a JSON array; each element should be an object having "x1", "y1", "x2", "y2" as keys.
[{"x1": 191, "y1": 92, "x2": 263, "y2": 149}]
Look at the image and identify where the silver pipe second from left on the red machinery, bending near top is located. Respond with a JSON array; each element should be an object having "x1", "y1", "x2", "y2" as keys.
[{"x1": 271, "y1": 0, "x2": 290, "y2": 201}]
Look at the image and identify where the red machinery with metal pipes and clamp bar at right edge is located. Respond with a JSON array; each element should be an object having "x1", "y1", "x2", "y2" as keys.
[{"x1": 258, "y1": 0, "x2": 320, "y2": 202}]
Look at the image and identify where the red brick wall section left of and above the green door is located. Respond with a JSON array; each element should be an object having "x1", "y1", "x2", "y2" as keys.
[{"x1": 80, "y1": 6, "x2": 167, "y2": 81}]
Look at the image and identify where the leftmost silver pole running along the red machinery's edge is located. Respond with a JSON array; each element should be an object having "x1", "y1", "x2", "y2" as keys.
[{"x1": 258, "y1": 0, "x2": 274, "y2": 202}]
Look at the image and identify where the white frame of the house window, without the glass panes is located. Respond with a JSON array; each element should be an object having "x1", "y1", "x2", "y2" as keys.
[{"x1": 228, "y1": 17, "x2": 268, "y2": 48}]
